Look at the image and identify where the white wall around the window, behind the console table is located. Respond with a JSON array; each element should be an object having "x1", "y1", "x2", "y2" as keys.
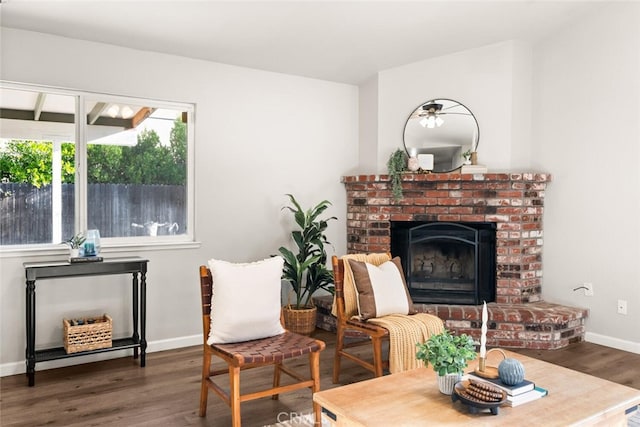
[{"x1": 0, "y1": 28, "x2": 358, "y2": 374}]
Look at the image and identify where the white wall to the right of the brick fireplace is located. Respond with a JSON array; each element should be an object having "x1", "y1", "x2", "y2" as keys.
[{"x1": 532, "y1": 3, "x2": 640, "y2": 352}]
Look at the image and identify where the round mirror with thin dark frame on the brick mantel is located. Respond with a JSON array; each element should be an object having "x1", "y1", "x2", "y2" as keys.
[{"x1": 404, "y1": 98, "x2": 480, "y2": 172}]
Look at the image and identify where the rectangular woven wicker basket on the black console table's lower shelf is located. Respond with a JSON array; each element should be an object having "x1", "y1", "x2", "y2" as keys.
[{"x1": 62, "y1": 314, "x2": 113, "y2": 353}]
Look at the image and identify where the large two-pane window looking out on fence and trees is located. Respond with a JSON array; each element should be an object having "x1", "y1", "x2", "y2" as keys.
[{"x1": 0, "y1": 84, "x2": 194, "y2": 249}]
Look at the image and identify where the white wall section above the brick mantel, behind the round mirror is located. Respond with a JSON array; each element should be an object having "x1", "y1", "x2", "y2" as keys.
[{"x1": 376, "y1": 41, "x2": 531, "y2": 173}]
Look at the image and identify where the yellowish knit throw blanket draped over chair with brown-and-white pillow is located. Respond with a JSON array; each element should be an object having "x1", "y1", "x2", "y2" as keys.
[{"x1": 332, "y1": 253, "x2": 444, "y2": 373}]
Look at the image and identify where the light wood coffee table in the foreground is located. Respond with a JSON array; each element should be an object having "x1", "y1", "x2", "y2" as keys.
[{"x1": 313, "y1": 351, "x2": 640, "y2": 427}]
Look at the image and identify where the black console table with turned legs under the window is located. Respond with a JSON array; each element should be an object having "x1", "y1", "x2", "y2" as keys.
[{"x1": 23, "y1": 257, "x2": 149, "y2": 386}]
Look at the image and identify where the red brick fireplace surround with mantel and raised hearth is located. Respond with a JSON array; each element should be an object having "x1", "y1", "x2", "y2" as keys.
[{"x1": 342, "y1": 173, "x2": 588, "y2": 349}]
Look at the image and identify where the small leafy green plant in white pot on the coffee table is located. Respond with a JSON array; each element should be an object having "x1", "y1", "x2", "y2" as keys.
[{"x1": 416, "y1": 329, "x2": 476, "y2": 394}]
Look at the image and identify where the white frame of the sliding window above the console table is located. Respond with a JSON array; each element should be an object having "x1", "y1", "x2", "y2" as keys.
[{"x1": 0, "y1": 80, "x2": 199, "y2": 258}]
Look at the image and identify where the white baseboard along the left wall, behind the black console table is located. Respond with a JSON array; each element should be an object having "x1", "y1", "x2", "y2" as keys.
[{"x1": 0, "y1": 335, "x2": 202, "y2": 377}]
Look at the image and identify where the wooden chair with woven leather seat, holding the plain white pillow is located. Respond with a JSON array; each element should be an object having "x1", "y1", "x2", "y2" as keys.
[{"x1": 199, "y1": 265, "x2": 325, "y2": 427}]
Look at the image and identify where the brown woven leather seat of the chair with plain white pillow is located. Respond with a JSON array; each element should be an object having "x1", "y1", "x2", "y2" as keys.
[{"x1": 216, "y1": 332, "x2": 324, "y2": 364}]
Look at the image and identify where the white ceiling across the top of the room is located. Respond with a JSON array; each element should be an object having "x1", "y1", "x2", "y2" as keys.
[{"x1": 0, "y1": 0, "x2": 607, "y2": 84}]
